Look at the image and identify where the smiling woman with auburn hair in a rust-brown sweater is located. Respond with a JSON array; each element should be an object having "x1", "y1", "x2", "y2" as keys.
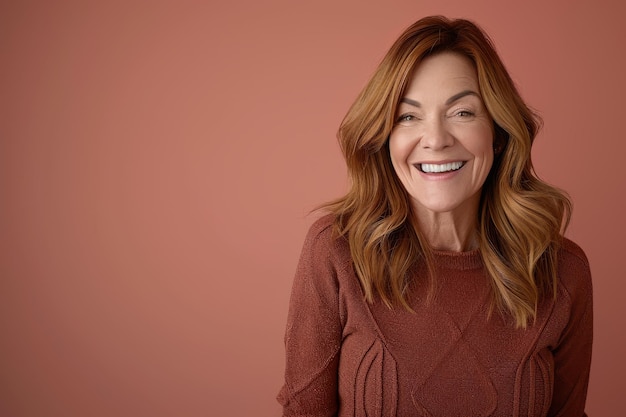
[{"x1": 278, "y1": 17, "x2": 592, "y2": 417}]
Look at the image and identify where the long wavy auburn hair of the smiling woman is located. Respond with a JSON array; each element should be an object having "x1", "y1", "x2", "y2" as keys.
[{"x1": 325, "y1": 16, "x2": 571, "y2": 328}]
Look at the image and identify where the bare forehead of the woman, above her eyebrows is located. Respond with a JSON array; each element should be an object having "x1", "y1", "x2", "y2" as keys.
[{"x1": 405, "y1": 52, "x2": 479, "y2": 98}]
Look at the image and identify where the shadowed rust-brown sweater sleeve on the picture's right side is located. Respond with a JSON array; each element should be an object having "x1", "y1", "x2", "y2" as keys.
[{"x1": 548, "y1": 242, "x2": 593, "y2": 417}]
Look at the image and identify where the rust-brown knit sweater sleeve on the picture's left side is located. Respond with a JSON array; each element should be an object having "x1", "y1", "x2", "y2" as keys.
[{"x1": 278, "y1": 221, "x2": 342, "y2": 417}]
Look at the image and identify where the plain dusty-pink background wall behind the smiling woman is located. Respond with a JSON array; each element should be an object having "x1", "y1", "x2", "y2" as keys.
[{"x1": 0, "y1": 0, "x2": 626, "y2": 417}]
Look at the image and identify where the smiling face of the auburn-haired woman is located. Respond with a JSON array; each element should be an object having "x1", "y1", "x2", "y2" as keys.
[{"x1": 389, "y1": 52, "x2": 494, "y2": 216}]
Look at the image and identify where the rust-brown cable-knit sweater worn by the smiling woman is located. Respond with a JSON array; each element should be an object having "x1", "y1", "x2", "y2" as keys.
[{"x1": 278, "y1": 216, "x2": 592, "y2": 417}]
